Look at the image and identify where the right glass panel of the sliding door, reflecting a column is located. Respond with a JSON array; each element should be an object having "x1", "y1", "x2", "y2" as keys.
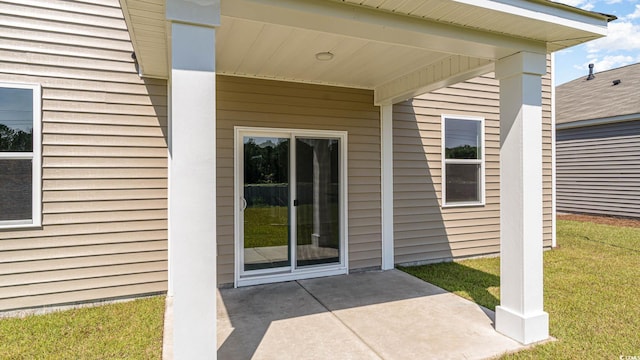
[{"x1": 295, "y1": 137, "x2": 340, "y2": 267}]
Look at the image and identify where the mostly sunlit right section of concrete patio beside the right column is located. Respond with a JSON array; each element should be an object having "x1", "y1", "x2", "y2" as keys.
[{"x1": 300, "y1": 270, "x2": 523, "y2": 359}]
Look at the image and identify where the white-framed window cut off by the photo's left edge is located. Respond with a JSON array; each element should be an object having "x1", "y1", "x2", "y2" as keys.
[{"x1": 0, "y1": 83, "x2": 41, "y2": 228}]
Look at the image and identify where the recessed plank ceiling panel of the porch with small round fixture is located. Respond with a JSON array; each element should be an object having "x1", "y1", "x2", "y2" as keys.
[{"x1": 216, "y1": 16, "x2": 448, "y2": 89}]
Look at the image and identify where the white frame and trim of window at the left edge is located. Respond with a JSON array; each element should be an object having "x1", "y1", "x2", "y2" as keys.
[{"x1": 0, "y1": 82, "x2": 42, "y2": 229}]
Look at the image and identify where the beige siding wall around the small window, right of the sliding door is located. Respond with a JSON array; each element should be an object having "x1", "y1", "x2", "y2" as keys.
[{"x1": 393, "y1": 62, "x2": 552, "y2": 264}]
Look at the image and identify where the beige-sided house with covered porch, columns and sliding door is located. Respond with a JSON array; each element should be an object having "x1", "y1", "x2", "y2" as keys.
[{"x1": 0, "y1": 0, "x2": 613, "y2": 359}]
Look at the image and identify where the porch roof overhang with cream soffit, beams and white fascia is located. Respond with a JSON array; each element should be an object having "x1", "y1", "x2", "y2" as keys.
[{"x1": 120, "y1": 0, "x2": 613, "y2": 103}]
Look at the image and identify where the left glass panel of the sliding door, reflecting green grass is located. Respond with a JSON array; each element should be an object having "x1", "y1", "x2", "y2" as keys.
[{"x1": 243, "y1": 136, "x2": 291, "y2": 271}]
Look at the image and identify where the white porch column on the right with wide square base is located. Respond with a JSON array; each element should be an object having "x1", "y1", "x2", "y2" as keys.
[{"x1": 496, "y1": 53, "x2": 549, "y2": 344}]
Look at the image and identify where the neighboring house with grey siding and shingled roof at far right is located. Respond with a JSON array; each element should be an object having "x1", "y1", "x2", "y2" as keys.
[{"x1": 556, "y1": 64, "x2": 640, "y2": 217}]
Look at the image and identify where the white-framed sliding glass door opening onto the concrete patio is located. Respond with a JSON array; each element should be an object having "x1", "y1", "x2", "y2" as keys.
[{"x1": 237, "y1": 130, "x2": 345, "y2": 277}]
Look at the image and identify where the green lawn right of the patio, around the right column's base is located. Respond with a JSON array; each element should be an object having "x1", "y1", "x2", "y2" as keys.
[{"x1": 402, "y1": 221, "x2": 640, "y2": 359}]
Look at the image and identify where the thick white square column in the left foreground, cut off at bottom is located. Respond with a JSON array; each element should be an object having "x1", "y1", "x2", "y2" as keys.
[{"x1": 165, "y1": 17, "x2": 219, "y2": 359}]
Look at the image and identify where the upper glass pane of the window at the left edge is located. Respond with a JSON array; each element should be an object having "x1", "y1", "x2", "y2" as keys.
[{"x1": 0, "y1": 87, "x2": 33, "y2": 152}]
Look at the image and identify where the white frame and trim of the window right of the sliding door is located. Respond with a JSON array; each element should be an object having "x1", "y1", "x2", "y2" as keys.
[{"x1": 440, "y1": 114, "x2": 487, "y2": 208}]
